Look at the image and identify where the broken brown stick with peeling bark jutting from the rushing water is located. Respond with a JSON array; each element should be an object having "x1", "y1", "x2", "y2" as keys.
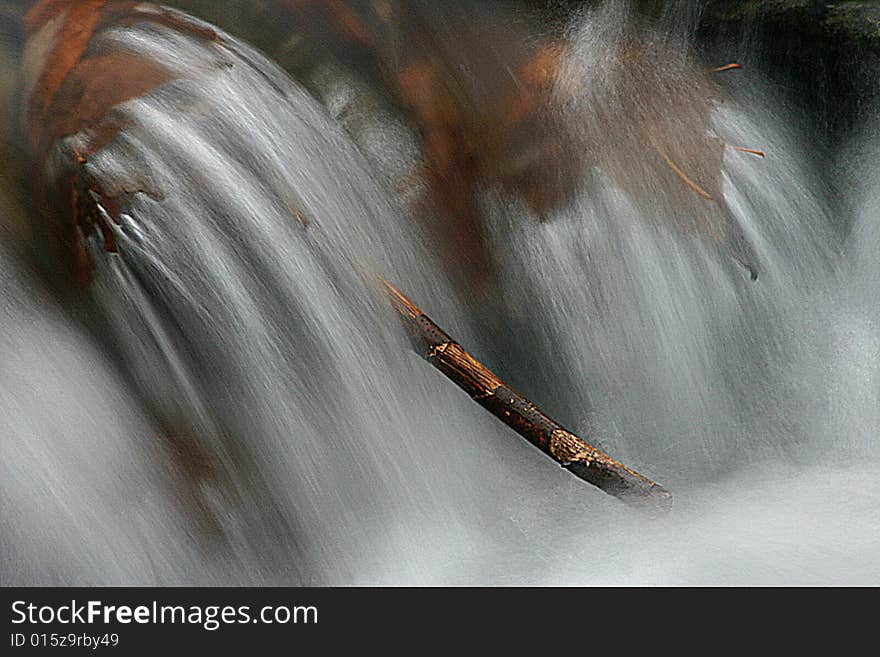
[{"x1": 383, "y1": 280, "x2": 672, "y2": 512}]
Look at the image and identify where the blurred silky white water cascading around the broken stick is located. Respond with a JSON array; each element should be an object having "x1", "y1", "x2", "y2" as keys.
[{"x1": 0, "y1": 4, "x2": 880, "y2": 584}]
